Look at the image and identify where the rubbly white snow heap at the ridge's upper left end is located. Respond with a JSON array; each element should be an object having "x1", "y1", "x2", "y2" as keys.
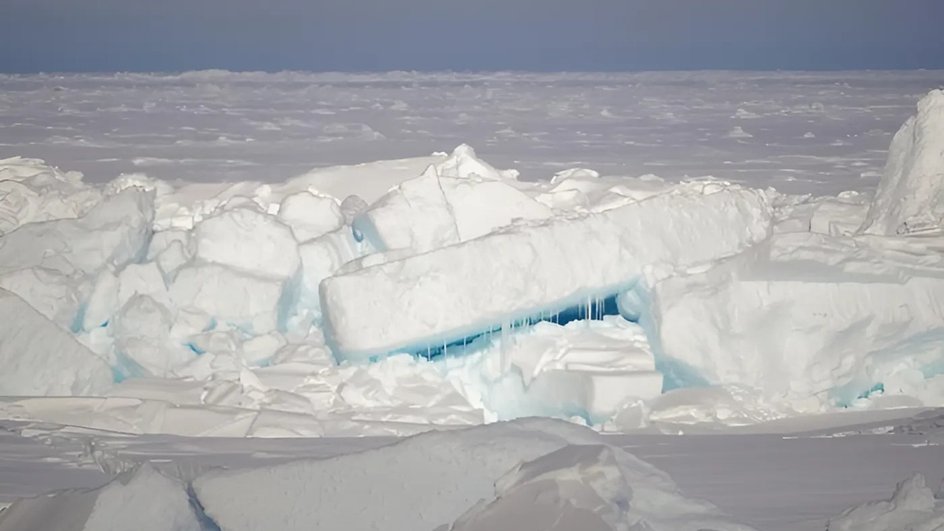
[{"x1": 0, "y1": 157, "x2": 102, "y2": 235}]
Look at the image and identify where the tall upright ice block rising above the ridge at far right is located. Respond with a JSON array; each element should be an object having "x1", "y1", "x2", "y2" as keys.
[{"x1": 862, "y1": 90, "x2": 944, "y2": 235}]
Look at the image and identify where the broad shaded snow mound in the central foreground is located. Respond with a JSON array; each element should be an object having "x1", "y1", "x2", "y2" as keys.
[{"x1": 193, "y1": 420, "x2": 748, "y2": 531}]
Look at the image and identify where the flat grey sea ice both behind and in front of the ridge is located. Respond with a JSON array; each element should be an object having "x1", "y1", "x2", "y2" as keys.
[{"x1": 0, "y1": 71, "x2": 944, "y2": 531}]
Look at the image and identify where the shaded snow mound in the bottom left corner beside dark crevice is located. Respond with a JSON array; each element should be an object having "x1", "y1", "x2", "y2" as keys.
[{"x1": 0, "y1": 464, "x2": 205, "y2": 531}]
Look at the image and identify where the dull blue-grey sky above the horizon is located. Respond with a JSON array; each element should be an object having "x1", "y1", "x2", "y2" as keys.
[{"x1": 0, "y1": 0, "x2": 944, "y2": 72}]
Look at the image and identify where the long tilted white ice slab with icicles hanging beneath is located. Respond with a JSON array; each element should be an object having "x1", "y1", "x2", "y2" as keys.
[{"x1": 321, "y1": 183, "x2": 770, "y2": 360}]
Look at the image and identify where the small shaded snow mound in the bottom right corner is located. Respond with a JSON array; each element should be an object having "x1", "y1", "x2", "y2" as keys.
[{"x1": 826, "y1": 474, "x2": 944, "y2": 531}]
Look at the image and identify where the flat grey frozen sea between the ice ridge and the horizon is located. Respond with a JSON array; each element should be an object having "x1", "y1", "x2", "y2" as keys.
[{"x1": 0, "y1": 71, "x2": 944, "y2": 195}]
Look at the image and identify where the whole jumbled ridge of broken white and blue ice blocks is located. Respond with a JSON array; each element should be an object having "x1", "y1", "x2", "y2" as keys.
[{"x1": 0, "y1": 91, "x2": 944, "y2": 434}]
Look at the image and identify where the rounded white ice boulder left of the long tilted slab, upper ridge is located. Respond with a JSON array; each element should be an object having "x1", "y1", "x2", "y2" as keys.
[{"x1": 193, "y1": 207, "x2": 299, "y2": 279}]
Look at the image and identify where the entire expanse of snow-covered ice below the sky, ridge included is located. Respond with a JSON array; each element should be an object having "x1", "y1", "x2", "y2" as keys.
[{"x1": 0, "y1": 71, "x2": 944, "y2": 531}]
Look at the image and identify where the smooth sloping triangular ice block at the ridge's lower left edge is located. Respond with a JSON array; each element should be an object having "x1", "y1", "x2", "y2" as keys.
[{"x1": 0, "y1": 289, "x2": 112, "y2": 396}]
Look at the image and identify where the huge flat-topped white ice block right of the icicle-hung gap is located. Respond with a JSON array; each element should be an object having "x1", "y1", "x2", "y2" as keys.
[{"x1": 643, "y1": 233, "x2": 944, "y2": 408}]
